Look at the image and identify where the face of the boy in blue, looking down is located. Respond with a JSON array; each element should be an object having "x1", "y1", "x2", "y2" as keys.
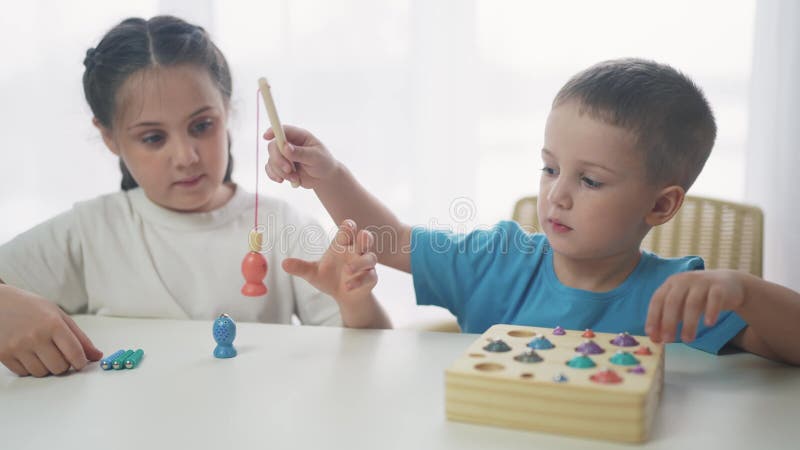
[{"x1": 538, "y1": 101, "x2": 657, "y2": 259}]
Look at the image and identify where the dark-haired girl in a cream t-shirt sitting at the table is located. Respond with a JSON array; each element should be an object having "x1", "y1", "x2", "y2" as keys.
[{"x1": 0, "y1": 16, "x2": 390, "y2": 376}]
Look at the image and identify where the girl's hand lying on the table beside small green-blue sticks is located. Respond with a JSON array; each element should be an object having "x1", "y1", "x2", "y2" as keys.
[{"x1": 0, "y1": 285, "x2": 103, "y2": 377}]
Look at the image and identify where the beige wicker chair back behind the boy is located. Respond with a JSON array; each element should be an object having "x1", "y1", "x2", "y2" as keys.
[{"x1": 512, "y1": 195, "x2": 764, "y2": 277}]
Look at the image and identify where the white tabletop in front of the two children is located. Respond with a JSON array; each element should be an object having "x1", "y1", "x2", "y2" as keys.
[{"x1": 0, "y1": 316, "x2": 800, "y2": 450}]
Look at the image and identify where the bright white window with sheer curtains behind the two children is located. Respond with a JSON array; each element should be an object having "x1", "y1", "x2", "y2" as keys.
[{"x1": 0, "y1": 0, "x2": 755, "y2": 326}]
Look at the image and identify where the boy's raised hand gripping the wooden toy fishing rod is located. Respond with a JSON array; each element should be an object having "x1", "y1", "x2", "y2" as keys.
[{"x1": 264, "y1": 125, "x2": 338, "y2": 189}]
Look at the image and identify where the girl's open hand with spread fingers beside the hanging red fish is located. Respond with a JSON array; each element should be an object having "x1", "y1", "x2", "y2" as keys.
[{"x1": 282, "y1": 219, "x2": 378, "y2": 307}]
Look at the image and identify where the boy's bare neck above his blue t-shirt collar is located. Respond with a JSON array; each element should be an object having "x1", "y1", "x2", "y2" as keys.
[{"x1": 553, "y1": 249, "x2": 642, "y2": 292}]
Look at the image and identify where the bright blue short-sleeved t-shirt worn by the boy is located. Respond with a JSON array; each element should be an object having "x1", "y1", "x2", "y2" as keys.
[{"x1": 411, "y1": 221, "x2": 747, "y2": 353}]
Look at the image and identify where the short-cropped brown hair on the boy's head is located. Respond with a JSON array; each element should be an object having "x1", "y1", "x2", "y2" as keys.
[{"x1": 553, "y1": 58, "x2": 717, "y2": 190}]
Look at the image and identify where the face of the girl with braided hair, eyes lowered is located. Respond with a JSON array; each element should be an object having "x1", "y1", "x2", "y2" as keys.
[{"x1": 96, "y1": 65, "x2": 233, "y2": 212}]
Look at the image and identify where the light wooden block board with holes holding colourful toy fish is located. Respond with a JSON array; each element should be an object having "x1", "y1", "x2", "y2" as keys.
[{"x1": 445, "y1": 325, "x2": 664, "y2": 442}]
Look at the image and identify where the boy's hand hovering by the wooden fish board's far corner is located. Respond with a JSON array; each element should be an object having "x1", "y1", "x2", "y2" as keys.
[{"x1": 644, "y1": 270, "x2": 745, "y2": 342}]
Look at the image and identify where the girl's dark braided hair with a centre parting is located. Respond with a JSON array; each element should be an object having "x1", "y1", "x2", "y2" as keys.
[{"x1": 83, "y1": 16, "x2": 233, "y2": 191}]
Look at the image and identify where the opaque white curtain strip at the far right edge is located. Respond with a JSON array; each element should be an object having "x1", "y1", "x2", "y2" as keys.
[{"x1": 746, "y1": 0, "x2": 800, "y2": 291}]
